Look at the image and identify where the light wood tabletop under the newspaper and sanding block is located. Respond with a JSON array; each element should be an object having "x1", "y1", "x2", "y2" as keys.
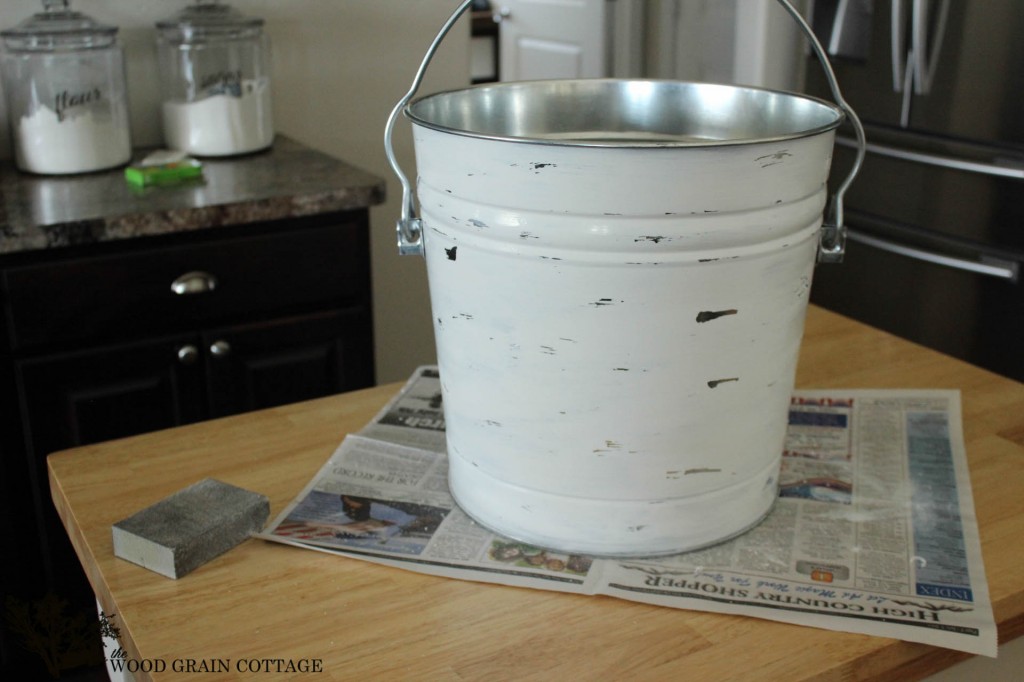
[{"x1": 48, "y1": 306, "x2": 1024, "y2": 681}]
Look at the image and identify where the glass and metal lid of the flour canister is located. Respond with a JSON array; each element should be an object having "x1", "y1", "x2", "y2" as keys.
[{"x1": 0, "y1": 0, "x2": 118, "y2": 51}]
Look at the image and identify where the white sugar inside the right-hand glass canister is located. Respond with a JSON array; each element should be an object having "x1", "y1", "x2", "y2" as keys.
[{"x1": 164, "y1": 80, "x2": 273, "y2": 157}]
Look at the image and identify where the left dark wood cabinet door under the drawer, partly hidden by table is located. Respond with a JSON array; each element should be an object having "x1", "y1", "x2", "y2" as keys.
[{"x1": 15, "y1": 336, "x2": 203, "y2": 630}]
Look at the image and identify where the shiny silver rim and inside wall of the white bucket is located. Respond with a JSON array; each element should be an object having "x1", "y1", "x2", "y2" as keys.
[{"x1": 403, "y1": 78, "x2": 846, "y2": 148}]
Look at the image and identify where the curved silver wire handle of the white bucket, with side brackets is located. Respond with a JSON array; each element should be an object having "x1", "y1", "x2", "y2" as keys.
[{"x1": 384, "y1": 0, "x2": 867, "y2": 263}]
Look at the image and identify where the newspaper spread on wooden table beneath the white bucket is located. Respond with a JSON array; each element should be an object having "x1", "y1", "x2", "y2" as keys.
[{"x1": 260, "y1": 367, "x2": 996, "y2": 656}]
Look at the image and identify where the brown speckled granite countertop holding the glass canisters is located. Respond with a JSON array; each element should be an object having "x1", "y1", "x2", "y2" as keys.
[{"x1": 0, "y1": 135, "x2": 384, "y2": 255}]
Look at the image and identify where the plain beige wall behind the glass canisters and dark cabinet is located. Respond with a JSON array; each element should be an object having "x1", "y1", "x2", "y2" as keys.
[{"x1": 0, "y1": 0, "x2": 469, "y2": 383}]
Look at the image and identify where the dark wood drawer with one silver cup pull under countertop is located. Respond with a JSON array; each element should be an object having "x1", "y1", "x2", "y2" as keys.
[{"x1": 3, "y1": 219, "x2": 369, "y2": 349}]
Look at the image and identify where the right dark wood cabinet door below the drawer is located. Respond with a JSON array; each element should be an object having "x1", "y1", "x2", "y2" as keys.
[{"x1": 202, "y1": 306, "x2": 374, "y2": 417}]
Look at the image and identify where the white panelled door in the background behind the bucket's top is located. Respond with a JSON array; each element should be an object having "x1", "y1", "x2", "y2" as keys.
[{"x1": 492, "y1": 0, "x2": 608, "y2": 81}]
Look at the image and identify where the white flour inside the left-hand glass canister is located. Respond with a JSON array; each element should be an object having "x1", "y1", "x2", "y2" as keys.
[{"x1": 14, "y1": 106, "x2": 131, "y2": 175}]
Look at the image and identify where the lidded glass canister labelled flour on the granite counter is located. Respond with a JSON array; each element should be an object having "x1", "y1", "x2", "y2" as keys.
[{"x1": 0, "y1": 0, "x2": 131, "y2": 174}]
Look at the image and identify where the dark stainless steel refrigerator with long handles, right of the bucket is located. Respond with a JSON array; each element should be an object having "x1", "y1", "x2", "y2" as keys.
[{"x1": 807, "y1": 0, "x2": 1024, "y2": 381}]
